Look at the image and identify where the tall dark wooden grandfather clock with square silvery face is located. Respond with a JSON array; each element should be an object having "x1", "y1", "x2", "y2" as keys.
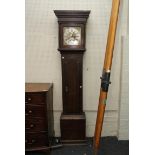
[{"x1": 54, "y1": 10, "x2": 90, "y2": 144}]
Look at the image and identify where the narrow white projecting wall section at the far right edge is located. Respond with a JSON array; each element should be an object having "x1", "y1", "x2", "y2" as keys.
[{"x1": 118, "y1": 0, "x2": 129, "y2": 140}]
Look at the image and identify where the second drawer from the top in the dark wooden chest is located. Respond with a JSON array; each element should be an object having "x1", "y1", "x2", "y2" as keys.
[{"x1": 25, "y1": 105, "x2": 47, "y2": 118}]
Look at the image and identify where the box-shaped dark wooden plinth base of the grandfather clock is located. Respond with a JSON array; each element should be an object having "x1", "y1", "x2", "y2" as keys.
[{"x1": 60, "y1": 113, "x2": 86, "y2": 145}]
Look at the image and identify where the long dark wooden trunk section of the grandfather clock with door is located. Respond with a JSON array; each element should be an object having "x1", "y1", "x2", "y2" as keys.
[{"x1": 62, "y1": 54, "x2": 82, "y2": 114}]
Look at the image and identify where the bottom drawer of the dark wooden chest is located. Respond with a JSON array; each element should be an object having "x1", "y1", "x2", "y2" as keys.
[{"x1": 25, "y1": 133, "x2": 49, "y2": 148}]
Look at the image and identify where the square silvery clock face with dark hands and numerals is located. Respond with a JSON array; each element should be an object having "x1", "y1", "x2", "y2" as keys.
[{"x1": 63, "y1": 27, "x2": 81, "y2": 46}]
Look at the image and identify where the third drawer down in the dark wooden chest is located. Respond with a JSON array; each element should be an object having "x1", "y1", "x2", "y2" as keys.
[{"x1": 25, "y1": 117, "x2": 48, "y2": 132}]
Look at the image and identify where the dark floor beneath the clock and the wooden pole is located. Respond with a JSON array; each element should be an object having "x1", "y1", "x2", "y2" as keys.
[{"x1": 25, "y1": 137, "x2": 129, "y2": 155}]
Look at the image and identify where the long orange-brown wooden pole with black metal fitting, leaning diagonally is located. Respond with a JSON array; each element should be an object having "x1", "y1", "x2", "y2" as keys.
[{"x1": 93, "y1": 0, "x2": 120, "y2": 155}]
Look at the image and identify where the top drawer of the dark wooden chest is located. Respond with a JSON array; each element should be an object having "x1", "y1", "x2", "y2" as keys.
[{"x1": 25, "y1": 92, "x2": 46, "y2": 104}]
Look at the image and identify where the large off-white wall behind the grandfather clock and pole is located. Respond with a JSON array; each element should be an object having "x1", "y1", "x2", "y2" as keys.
[{"x1": 25, "y1": 0, "x2": 128, "y2": 139}]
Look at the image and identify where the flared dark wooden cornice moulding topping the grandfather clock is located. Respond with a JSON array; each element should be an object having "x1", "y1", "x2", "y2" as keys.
[{"x1": 54, "y1": 10, "x2": 90, "y2": 23}]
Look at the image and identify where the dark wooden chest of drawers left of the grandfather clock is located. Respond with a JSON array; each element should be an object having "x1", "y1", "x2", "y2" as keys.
[{"x1": 25, "y1": 83, "x2": 54, "y2": 151}]
